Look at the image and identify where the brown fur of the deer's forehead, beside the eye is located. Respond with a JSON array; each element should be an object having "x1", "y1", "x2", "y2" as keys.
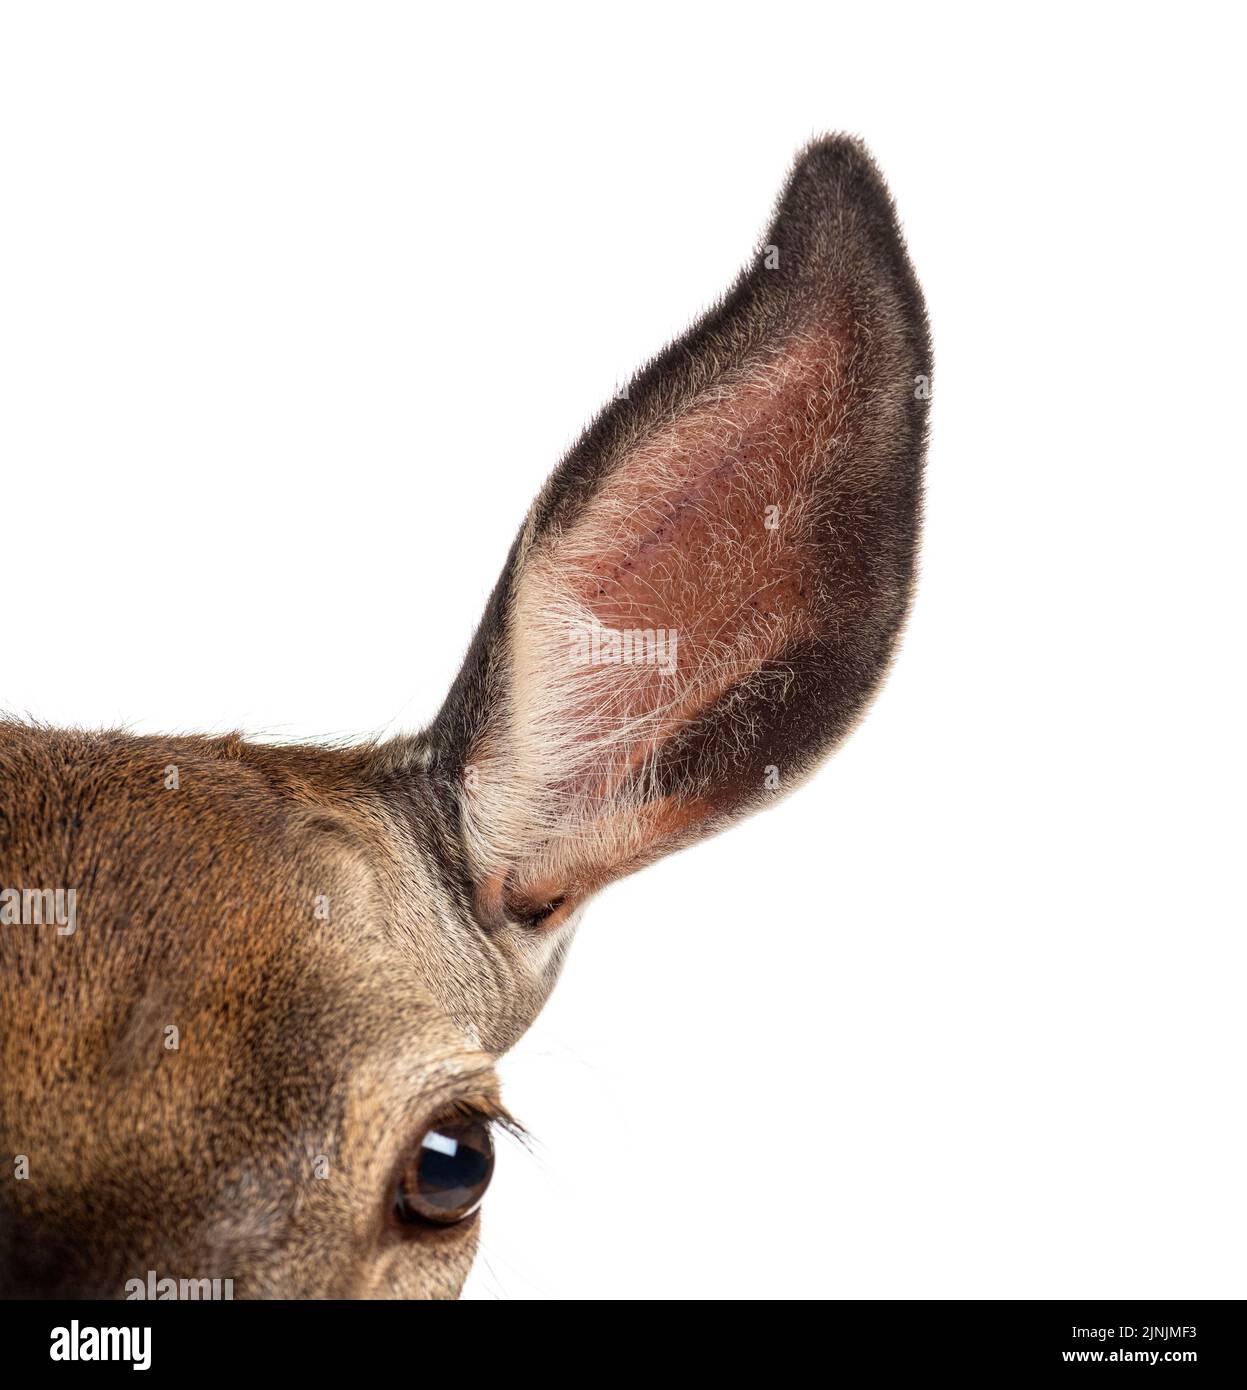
[{"x1": 0, "y1": 724, "x2": 517, "y2": 1295}]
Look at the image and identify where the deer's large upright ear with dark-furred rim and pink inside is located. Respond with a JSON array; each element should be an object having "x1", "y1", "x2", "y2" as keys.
[{"x1": 431, "y1": 138, "x2": 930, "y2": 924}]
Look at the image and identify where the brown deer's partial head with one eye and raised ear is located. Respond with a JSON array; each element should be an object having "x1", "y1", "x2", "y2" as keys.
[{"x1": 0, "y1": 135, "x2": 931, "y2": 1300}]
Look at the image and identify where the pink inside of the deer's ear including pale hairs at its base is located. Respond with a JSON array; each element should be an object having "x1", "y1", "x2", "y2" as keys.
[{"x1": 473, "y1": 314, "x2": 895, "y2": 924}]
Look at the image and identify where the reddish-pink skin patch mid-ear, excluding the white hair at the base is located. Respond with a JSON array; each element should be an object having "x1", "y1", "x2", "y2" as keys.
[{"x1": 530, "y1": 323, "x2": 849, "y2": 773}]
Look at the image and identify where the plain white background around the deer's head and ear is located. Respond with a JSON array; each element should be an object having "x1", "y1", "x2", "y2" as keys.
[{"x1": 0, "y1": 3, "x2": 1247, "y2": 1297}]
